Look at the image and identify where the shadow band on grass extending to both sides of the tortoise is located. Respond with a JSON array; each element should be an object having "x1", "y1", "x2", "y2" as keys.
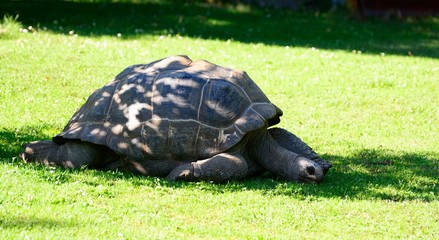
[{"x1": 0, "y1": 126, "x2": 439, "y2": 201}]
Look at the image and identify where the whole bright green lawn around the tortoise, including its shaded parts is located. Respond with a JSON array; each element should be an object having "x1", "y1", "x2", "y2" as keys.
[{"x1": 0, "y1": 1, "x2": 439, "y2": 239}]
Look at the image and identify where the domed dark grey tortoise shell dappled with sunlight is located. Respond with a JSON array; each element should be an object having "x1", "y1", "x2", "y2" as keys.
[{"x1": 53, "y1": 56, "x2": 282, "y2": 161}]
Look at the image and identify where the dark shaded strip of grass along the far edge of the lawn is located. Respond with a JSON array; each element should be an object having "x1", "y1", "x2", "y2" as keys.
[{"x1": 0, "y1": 0, "x2": 439, "y2": 58}]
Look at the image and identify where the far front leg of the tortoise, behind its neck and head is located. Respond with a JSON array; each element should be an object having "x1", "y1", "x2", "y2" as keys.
[{"x1": 268, "y1": 128, "x2": 332, "y2": 174}]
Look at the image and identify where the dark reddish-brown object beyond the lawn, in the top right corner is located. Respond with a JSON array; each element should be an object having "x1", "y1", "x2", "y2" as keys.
[{"x1": 348, "y1": 0, "x2": 439, "y2": 17}]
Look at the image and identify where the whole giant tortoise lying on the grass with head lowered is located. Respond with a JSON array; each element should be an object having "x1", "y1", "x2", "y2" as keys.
[{"x1": 20, "y1": 56, "x2": 331, "y2": 183}]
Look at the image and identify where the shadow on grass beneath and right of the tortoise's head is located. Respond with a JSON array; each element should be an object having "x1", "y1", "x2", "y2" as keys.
[{"x1": 161, "y1": 149, "x2": 439, "y2": 202}]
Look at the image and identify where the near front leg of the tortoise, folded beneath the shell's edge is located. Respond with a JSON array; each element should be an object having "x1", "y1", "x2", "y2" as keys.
[{"x1": 167, "y1": 153, "x2": 247, "y2": 182}]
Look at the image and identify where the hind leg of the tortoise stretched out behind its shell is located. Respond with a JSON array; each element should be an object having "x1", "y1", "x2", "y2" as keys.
[{"x1": 19, "y1": 141, "x2": 102, "y2": 169}]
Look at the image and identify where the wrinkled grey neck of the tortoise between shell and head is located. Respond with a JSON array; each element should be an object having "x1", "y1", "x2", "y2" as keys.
[{"x1": 247, "y1": 129, "x2": 299, "y2": 178}]
